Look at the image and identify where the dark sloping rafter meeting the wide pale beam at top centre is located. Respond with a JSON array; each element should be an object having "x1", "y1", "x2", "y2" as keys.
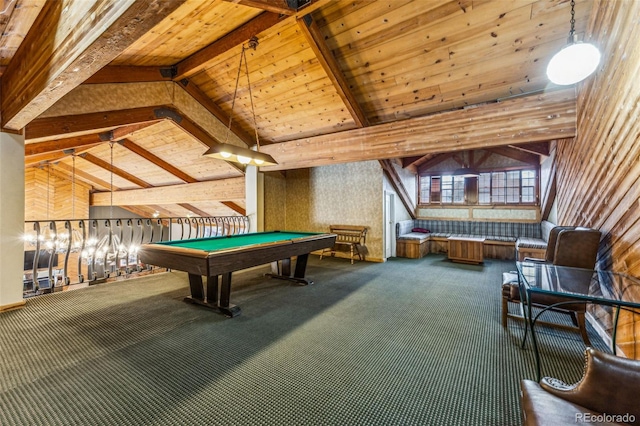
[{"x1": 298, "y1": 14, "x2": 369, "y2": 127}]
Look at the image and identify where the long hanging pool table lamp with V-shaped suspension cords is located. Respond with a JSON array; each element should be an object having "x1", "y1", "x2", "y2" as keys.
[{"x1": 203, "y1": 36, "x2": 278, "y2": 166}]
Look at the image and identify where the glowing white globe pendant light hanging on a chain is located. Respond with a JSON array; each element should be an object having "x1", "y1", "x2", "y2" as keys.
[{"x1": 547, "y1": 0, "x2": 600, "y2": 86}]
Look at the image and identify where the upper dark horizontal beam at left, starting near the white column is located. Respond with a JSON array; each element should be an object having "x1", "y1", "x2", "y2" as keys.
[{"x1": 25, "y1": 106, "x2": 164, "y2": 140}]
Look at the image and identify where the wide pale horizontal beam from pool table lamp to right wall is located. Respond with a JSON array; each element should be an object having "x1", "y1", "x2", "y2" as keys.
[{"x1": 261, "y1": 88, "x2": 576, "y2": 171}]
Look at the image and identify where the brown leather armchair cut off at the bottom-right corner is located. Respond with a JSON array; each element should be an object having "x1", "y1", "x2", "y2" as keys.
[{"x1": 520, "y1": 348, "x2": 640, "y2": 426}]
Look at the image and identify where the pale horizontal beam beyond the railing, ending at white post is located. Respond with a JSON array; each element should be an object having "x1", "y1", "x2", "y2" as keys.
[{"x1": 91, "y1": 177, "x2": 245, "y2": 206}]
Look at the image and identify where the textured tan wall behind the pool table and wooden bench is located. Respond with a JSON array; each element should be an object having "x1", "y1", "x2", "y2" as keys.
[{"x1": 265, "y1": 161, "x2": 383, "y2": 261}]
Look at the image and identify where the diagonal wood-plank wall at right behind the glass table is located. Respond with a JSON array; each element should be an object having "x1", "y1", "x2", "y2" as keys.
[{"x1": 557, "y1": 1, "x2": 640, "y2": 358}]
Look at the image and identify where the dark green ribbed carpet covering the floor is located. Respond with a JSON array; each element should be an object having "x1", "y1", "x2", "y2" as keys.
[{"x1": 0, "y1": 255, "x2": 601, "y2": 426}]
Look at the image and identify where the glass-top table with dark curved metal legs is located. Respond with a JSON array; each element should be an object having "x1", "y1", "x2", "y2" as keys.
[{"x1": 516, "y1": 262, "x2": 640, "y2": 381}]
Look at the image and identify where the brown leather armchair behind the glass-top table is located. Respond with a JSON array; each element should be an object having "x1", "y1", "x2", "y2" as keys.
[{"x1": 502, "y1": 226, "x2": 600, "y2": 346}]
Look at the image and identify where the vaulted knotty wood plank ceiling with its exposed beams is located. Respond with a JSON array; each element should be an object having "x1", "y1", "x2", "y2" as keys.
[{"x1": 6, "y1": 0, "x2": 593, "y2": 215}]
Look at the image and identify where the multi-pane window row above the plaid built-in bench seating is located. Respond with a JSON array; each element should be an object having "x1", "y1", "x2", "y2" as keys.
[{"x1": 418, "y1": 169, "x2": 538, "y2": 205}]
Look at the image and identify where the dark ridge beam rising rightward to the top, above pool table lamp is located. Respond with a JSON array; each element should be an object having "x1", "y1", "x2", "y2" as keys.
[{"x1": 174, "y1": 12, "x2": 286, "y2": 81}]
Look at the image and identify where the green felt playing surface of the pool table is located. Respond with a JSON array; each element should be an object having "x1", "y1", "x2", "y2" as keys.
[{"x1": 156, "y1": 231, "x2": 322, "y2": 252}]
